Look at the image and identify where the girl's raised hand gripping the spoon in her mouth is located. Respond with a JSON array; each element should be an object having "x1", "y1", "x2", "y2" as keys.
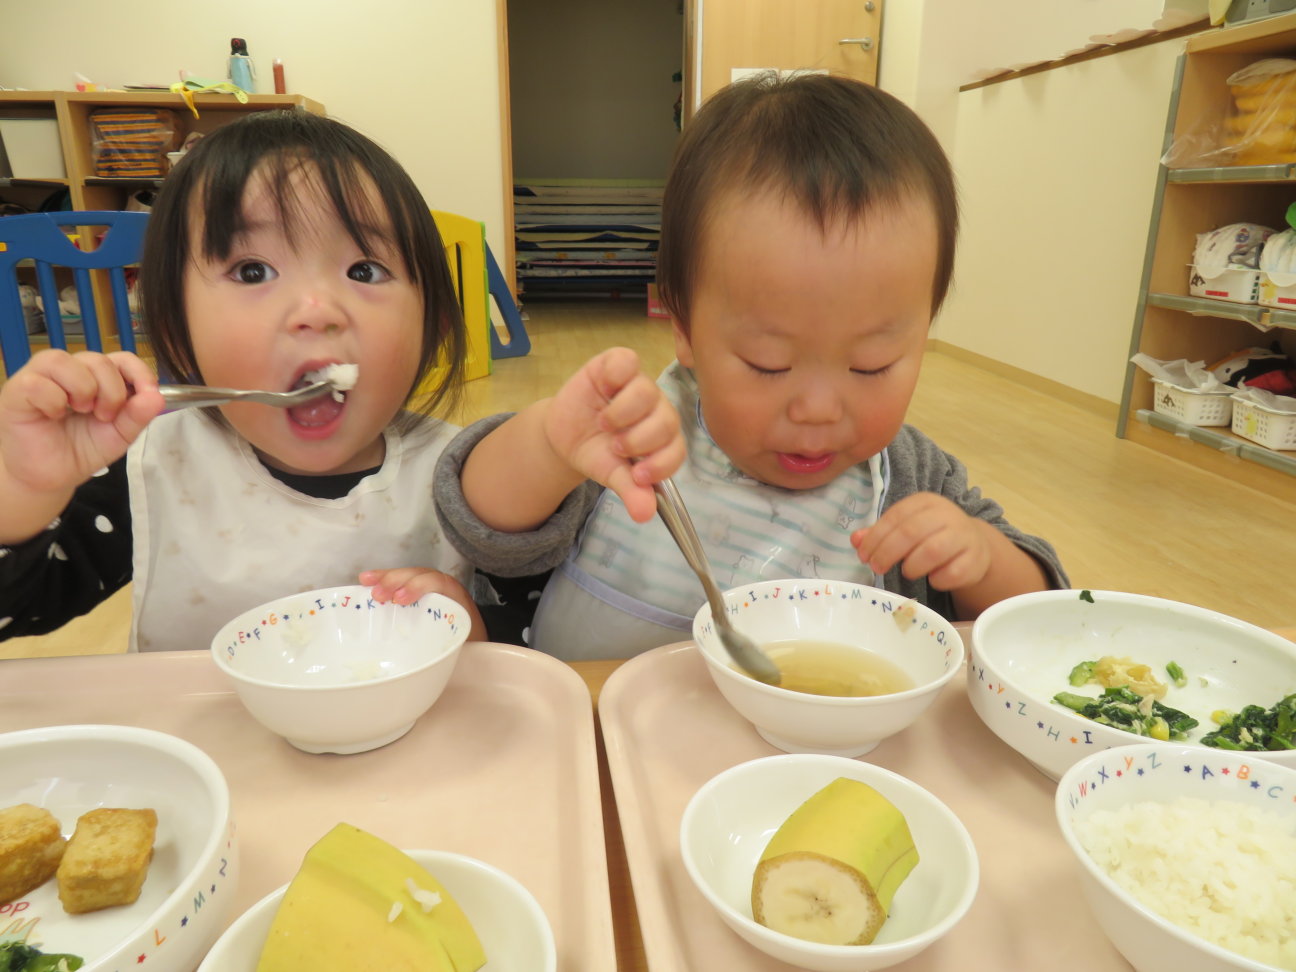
[{"x1": 0, "y1": 349, "x2": 166, "y2": 492}]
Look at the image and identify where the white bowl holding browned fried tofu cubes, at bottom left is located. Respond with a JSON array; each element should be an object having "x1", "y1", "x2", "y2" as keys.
[{"x1": 0, "y1": 726, "x2": 238, "y2": 972}]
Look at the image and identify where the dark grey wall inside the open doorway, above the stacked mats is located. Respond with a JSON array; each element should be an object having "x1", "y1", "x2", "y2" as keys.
[{"x1": 508, "y1": 0, "x2": 684, "y2": 179}]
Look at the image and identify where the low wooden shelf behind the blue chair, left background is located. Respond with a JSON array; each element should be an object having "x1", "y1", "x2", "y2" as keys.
[{"x1": 0, "y1": 91, "x2": 324, "y2": 346}]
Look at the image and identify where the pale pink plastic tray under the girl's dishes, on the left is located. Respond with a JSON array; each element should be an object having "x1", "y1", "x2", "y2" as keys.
[{"x1": 0, "y1": 644, "x2": 616, "y2": 972}]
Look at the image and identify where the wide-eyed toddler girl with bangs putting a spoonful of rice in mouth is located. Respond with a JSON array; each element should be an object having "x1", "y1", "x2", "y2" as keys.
[{"x1": 0, "y1": 111, "x2": 668, "y2": 651}]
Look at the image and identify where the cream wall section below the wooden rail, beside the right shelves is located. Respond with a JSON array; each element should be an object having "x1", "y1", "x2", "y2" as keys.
[{"x1": 934, "y1": 40, "x2": 1183, "y2": 402}]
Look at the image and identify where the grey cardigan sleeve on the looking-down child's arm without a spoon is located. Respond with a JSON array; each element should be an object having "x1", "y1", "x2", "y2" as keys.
[{"x1": 884, "y1": 425, "x2": 1070, "y2": 618}]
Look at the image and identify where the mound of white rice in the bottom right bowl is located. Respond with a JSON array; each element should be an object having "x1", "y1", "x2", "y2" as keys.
[{"x1": 1074, "y1": 797, "x2": 1296, "y2": 969}]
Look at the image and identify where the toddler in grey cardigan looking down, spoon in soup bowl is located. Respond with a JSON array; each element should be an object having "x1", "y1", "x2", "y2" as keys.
[{"x1": 437, "y1": 75, "x2": 1068, "y2": 660}]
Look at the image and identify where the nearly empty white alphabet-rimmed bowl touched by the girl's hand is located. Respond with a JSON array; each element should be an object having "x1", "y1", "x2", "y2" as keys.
[{"x1": 211, "y1": 587, "x2": 472, "y2": 753}]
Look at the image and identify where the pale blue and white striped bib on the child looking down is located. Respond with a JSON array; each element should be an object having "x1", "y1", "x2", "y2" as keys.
[{"x1": 562, "y1": 362, "x2": 885, "y2": 623}]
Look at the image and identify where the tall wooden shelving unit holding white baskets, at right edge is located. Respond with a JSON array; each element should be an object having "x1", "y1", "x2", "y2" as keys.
[{"x1": 1117, "y1": 13, "x2": 1296, "y2": 502}]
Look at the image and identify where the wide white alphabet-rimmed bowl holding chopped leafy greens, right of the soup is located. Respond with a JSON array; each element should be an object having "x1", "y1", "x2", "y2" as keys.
[{"x1": 968, "y1": 591, "x2": 1296, "y2": 780}]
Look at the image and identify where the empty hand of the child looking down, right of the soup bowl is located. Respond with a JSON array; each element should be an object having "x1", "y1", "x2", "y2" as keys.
[{"x1": 850, "y1": 492, "x2": 1051, "y2": 621}]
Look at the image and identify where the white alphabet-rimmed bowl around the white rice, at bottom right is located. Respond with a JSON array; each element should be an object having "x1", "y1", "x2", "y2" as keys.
[{"x1": 1056, "y1": 743, "x2": 1296, "y2": 972}]
